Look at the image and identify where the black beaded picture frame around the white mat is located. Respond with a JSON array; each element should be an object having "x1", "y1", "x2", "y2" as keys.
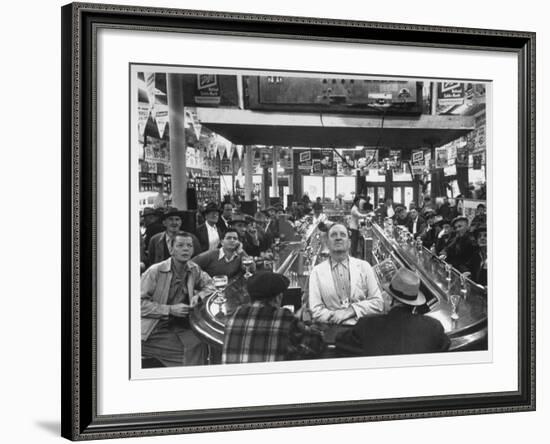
[{"x1": 61, "y1": 3, "x2": 535, "y2": 440}]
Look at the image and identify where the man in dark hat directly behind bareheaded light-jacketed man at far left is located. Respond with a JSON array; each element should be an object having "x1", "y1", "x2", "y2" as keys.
[{"x1": 147, "y1": 207, "x2": 202, "y2": 266}]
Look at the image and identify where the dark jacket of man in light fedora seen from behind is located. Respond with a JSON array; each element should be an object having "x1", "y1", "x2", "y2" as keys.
[{"x1": 336, "y1": 306, "x2": 450, "y2": 356}]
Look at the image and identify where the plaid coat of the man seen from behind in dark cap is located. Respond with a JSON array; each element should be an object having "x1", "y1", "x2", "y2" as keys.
[{"x1": 222, "y1": 301, "x2": 324, "y2": 364}]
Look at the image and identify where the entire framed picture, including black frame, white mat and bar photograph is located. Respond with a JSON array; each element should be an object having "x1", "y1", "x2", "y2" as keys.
[{"x1": 56, "y1": 4, "x2": 535, "y2": 440}]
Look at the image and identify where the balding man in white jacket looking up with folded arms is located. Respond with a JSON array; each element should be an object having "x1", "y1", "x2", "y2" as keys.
[{"x1": 309, "y1": 223, "x2": 384, "y2": 325}]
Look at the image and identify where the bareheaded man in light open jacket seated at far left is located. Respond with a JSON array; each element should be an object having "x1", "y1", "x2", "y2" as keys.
[{"x1": 141, "y1": 231, "x2": 215, "y2": 367}]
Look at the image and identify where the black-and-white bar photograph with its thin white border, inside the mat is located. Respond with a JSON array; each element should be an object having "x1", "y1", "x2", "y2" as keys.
[{"x1": 134, "y1": 67, "x2": 493, "y2": 379}]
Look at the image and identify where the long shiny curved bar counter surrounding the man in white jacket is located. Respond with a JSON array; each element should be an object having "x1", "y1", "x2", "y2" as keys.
[{"x1": 190, "y1": 215, "x2": 487, "y2": 358}]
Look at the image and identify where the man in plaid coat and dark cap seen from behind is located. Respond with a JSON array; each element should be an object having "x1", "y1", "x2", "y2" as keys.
[{"x1": 222, "y1": 271, "x2": 324, "y2": 364}]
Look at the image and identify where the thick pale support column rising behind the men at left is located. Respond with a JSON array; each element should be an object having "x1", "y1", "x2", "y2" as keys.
[{"x1": 166, "y1": 74, "x2": 187, "y2": 210}]
